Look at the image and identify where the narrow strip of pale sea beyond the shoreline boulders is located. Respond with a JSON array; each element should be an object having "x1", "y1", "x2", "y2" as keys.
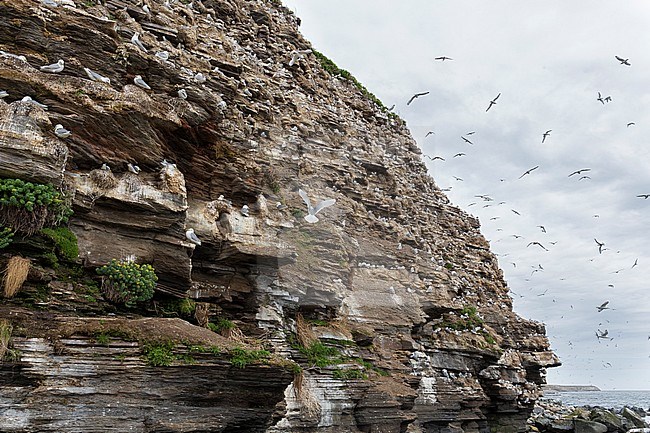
[{"x1": 544, "y1": 390, "x2": 650, "y2": 411}]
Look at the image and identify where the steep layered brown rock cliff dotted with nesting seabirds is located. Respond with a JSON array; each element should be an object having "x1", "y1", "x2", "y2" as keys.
[{"x1": 0, "y1": 0, "x2": 558, "y2": 433}]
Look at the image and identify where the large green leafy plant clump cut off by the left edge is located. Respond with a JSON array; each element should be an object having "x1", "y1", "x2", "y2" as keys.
[{"x1": 0, "y1": 179, "x2": 72, "y2": 236}]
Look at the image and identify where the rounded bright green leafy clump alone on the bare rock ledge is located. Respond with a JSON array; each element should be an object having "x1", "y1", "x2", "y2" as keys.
[{"x1": 97, "y1": 259, "x2": 158, "y2": 306}]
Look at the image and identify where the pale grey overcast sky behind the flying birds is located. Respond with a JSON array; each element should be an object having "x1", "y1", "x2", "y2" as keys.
[{"x1": 283, "y1": 0, "x2": 650, "y2": 389}]
